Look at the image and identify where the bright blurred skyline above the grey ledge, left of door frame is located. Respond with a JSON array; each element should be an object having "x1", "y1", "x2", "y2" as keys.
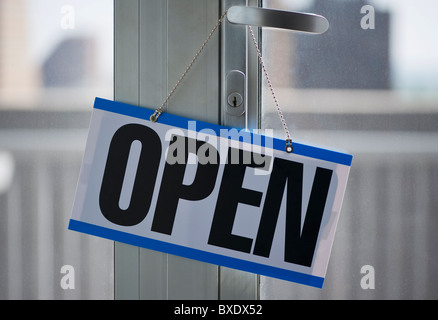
[{"x1": 0, "y1": 0, "x2": 113, "y2": 110}]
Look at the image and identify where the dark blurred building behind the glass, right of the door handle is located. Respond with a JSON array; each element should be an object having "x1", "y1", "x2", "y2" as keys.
[{"x1": 292, "y1": 0, "x2": 391, "y2": 90}]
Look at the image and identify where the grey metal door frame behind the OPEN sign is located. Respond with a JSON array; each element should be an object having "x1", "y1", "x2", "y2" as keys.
[{"x1": 114, "y1": 0, "x2": 261, "y2": 299}]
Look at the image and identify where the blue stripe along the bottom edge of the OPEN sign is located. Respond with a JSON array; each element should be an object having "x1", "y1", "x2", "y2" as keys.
[{"x1": 68, "y1": 219, "x2": 324, "y2": 288}]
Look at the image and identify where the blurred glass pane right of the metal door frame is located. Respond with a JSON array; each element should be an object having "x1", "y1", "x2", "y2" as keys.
[{"x1": 261, "y1": 0, "x2": 438, "y2": 299}]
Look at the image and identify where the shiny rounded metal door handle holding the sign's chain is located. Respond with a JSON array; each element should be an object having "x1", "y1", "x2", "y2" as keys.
[{"x1": 227, "y1": 6, "x2": 329, "y2": 33}]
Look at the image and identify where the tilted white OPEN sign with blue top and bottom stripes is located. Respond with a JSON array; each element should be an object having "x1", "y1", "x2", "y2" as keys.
[{"x1": 69, "y1": 98, "x2": 352, "y2": 288}]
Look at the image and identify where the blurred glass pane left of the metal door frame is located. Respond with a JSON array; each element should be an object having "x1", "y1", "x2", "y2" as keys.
[{"x1": 0, "y1": 0, "x2": 114, "y2": 299}]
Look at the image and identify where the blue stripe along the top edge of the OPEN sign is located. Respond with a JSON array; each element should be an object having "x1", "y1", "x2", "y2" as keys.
[{"x1": 94, "y1": 98, "x2": 353, "y2": 166}]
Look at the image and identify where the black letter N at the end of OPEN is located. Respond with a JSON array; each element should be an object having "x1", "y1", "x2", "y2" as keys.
[{"x1": 253, "y1": 158, "x2": 333, "y2": 267}]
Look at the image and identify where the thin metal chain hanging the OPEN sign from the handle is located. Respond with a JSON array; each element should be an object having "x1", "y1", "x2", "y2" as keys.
[{"x1": 150, "y1": 11, "x2": 293, "y2": 153}]
